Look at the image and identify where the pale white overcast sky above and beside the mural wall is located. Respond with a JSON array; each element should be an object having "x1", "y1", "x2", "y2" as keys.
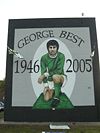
[{"x1": 0, "y1": 0, "x2": 100, "y2": 80}]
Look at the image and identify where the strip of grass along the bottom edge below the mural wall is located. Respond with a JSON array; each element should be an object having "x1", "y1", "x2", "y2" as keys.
[{"x1": 0, "y1": 124, "x2": 100, "y2": 133}]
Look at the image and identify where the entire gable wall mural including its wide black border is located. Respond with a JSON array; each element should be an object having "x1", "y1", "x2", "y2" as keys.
[{"x1": 5, "y1": 18, "x2": 100, "y2": 122}]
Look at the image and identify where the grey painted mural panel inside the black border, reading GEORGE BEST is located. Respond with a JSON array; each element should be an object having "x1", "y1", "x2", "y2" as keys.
[{"x1": 12, "y1": 27, "x2": 95, "y2": 109}]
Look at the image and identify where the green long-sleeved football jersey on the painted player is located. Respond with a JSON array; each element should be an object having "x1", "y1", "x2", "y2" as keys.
[{"x1": 40, "y1": 52, "x2": 65, "y2": 82}]
